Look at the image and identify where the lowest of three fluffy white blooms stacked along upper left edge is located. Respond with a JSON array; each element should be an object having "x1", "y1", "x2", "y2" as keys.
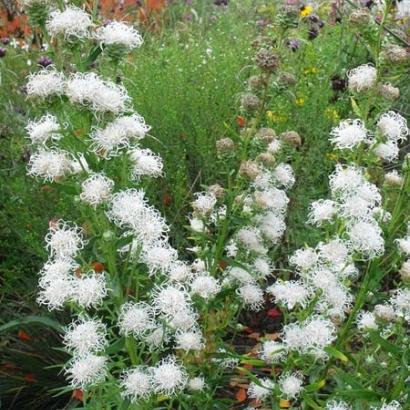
[{"x1": 27, "y1": 149, "x2": 73, "y2": 182}]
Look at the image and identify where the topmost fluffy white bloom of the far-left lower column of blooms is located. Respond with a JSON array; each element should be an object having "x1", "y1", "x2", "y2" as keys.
[{"x1": 45, "y1": 219, "x2": 84, "y2": 259}]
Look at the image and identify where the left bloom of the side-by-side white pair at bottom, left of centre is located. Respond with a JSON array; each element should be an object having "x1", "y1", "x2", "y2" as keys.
[{"x1": 120, "y1": 366, "x2": 153, "y2": 402}]
